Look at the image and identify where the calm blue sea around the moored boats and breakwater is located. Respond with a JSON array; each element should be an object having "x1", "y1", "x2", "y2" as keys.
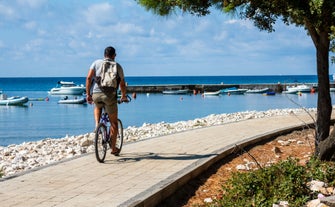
[{"x1": 0, "y1": 75, "x2": 333, "y2": 146}]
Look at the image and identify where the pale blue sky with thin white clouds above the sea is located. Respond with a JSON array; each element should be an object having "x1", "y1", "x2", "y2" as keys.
[{"x1": 0, "y1": 0, "x2": 320, "y2": 77}]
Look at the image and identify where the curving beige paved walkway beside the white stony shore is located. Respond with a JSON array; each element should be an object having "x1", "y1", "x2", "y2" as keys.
[{"x1": 0, "y1": 114, "x2": 324, "y2": 207}]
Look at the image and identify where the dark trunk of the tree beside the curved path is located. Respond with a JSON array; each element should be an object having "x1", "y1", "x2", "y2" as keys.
[{"x1": 315, "y1": 32, "x2": 335, "y2": 160}]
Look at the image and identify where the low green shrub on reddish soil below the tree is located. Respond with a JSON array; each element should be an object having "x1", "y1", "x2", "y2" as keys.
[{"x1": 209, "y1": 159, "x2": 335, "y2": 207}]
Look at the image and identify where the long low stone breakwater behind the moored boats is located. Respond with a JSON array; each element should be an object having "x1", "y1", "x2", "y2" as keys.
[{"x1": 127, "y1": 83, "x2": 322, "y2": 93}]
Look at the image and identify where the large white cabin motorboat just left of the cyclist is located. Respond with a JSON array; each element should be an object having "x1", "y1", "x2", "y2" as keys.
[{"x1": 49, "y1": 81, "x2": 86, "y2": 95}]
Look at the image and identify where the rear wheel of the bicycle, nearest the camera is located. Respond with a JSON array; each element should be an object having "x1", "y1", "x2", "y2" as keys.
[{"x1": 94, "y1": 123, "x2": 109, "y2": 162}]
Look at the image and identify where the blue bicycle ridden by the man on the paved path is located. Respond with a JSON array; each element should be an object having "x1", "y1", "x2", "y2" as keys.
[{"x1": 94, "y1": 95, "x2": 131, "y2": 163}]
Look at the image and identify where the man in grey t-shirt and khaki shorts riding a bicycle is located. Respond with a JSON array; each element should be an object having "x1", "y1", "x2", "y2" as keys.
[{"x1": 86, "y1": 46, "x2": 128, "y2": 155}]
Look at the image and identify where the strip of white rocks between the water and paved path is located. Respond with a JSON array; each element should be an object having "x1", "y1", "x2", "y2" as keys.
[{"x1": 0, "y1": 108, "x2": 316, "y2": 178}]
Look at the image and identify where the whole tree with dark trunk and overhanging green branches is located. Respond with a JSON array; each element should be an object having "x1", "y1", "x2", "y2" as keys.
[{"x1": 135, "y1": 0, "x2": 335, "y2": 160}]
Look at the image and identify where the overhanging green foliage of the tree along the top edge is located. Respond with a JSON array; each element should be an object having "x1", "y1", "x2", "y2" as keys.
[{"x1": 136, "y1": 0, "x2": 335, "y2": 34}]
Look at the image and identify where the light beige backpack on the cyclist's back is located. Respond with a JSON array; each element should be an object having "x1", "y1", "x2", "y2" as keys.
[{"x1": 95, "y1": 60, "x2": 120, "y2": 98}]
